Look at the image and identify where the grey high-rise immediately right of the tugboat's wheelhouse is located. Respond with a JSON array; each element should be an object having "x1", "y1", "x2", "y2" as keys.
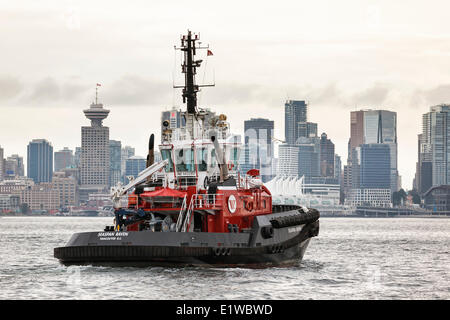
[{"x1": 244, "y1": 118, "x2": 274, "y2": 182}]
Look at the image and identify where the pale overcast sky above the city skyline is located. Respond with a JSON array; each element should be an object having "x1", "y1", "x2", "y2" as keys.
[{"x1": 0, "y1": 0, "x2": 450, "y2": 189}]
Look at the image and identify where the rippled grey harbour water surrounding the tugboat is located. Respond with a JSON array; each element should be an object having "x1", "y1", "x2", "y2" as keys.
[{"x1": 0, "y1": 217, "x2": 450, "y2": 300}]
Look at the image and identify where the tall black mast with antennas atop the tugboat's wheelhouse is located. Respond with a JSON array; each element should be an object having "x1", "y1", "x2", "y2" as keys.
[{"x1": 173, "y1": 30, "x2": 214, "y2": 138}]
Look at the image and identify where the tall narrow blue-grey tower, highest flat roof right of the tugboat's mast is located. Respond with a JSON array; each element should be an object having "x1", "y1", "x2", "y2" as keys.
[{"x1": 284, "y1": 100, "x2": 308, "y2": 145}]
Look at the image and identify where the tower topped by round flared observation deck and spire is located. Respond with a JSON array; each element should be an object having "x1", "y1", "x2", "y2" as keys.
[{"x1": 80, "y1": 101, "x2": 110, "y2": 202}]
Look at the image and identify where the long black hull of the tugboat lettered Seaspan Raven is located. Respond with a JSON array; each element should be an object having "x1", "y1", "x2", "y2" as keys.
[{"x1": 54, "y1": 208, "x2": 319, "y2": 268}]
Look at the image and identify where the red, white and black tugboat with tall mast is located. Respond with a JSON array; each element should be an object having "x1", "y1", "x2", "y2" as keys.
[{"x1": 54, "y1": 31, "x2": 319, "y2": 267}]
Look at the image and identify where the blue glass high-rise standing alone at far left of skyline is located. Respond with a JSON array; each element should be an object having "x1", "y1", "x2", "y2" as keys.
[{"x1": 27, "y1": 139, "x2": 53, "y2": 183}]
